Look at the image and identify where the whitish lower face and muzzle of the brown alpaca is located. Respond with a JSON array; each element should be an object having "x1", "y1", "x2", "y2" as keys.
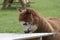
[{"x1": 20, "y1": 21, "x2": 37, "y2": 33}]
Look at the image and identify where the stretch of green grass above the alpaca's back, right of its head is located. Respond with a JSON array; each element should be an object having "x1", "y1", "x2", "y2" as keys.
[{"x1": 31, "y1": 0, "x2": 60, "y2": 17}]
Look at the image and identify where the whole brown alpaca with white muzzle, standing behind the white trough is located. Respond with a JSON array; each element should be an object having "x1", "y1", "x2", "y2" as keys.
[{"x1": 19, "y1": 8, "x2": 60, "y2": 40}]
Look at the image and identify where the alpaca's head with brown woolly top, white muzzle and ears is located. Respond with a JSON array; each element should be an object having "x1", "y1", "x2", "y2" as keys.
[{"x1": 19, "y1": 8, "x2": 37, "y2": 33}]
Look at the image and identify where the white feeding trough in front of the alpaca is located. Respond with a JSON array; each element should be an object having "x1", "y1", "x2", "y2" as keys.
[{"x1": 0, "y1": 33, "x2": 54, "y2": 40}]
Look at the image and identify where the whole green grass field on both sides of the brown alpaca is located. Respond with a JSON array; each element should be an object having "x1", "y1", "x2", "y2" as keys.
[{"x1": 0, "y1": 0, "x2": 60, "y2": 33}]
